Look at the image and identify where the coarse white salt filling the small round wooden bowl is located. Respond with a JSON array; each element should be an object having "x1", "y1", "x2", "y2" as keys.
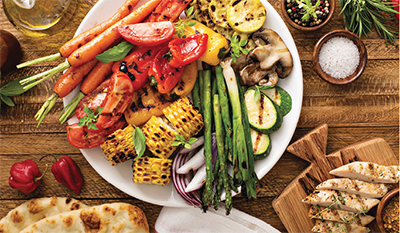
[{"x1": 319, "y1": 36, "x2": 360, "y2": 79}]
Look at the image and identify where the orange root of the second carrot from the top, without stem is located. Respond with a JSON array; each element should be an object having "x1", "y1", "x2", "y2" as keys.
[{"x1": 68, "y1": 0, "x2": 161, "y2": 66}]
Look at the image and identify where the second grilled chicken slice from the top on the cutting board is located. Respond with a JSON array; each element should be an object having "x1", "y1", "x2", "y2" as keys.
[{"x1": 315, "y1": 178, "x2": 390, "y2": 198}]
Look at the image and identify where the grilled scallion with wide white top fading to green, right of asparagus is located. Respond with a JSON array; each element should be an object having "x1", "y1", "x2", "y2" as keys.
[{"x1": 220, "y1": 58, "x2": 251, "y2": 182}]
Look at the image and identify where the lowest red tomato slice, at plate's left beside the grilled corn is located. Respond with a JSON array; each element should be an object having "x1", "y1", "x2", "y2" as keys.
[{"x1": 67, "y1": 120, "x2": 125, "y2": 149}]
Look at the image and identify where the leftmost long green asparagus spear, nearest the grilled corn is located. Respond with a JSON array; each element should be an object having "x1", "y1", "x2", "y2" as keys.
[{"x1": 202, "y1": 70, "x2": 214, "y2": 206}]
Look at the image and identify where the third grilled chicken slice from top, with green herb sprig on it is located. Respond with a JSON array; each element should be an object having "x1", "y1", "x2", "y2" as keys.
[{"x1": 302, "y1": 190, "x2": 379, "y2": 213}]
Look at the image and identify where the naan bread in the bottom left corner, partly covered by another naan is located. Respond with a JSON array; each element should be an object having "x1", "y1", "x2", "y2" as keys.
[{"x1": 0, "y1": 197, "x2": 87, "y2": 233}]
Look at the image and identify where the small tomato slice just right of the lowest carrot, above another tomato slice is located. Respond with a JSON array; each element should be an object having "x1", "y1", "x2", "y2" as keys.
[{"x1": 76, "y1": 79, "x2": 110, "y2": 119}]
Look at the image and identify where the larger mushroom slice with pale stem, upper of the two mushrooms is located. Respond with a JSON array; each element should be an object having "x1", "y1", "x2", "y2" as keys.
[{"x1": 247, "y1": 28, "x2": 293, "y2": 78}]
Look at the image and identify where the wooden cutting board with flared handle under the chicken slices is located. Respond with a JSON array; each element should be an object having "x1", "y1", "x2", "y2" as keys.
[{"x1": 272, "y1": 124, "x2": 399, "y2": 233}]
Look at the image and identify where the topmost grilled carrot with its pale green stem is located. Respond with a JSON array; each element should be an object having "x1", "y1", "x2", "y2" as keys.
[{"x1": 17, "y1": 0, "x2": 140, "y2": 69}]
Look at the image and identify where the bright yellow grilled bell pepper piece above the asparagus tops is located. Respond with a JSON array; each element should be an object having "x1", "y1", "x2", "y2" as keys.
[{"x1": 185, "y1": 20, "x2": 229, "y2": 66}]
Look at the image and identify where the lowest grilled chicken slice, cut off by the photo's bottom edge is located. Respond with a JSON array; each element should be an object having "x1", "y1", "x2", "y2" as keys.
[{"x1": 311, "y1": 220, "x2": 371, "y2": 233}]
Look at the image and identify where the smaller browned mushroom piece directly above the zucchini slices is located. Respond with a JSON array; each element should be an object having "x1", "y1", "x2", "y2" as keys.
[{"x1": 239, "y1": 62, "x2": 279, "y2": 86}]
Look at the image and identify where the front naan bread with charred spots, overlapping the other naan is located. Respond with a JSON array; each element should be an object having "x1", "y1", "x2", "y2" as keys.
[{"x1": 21, "y1": 203, "x2": 149, "y2": 233}]
